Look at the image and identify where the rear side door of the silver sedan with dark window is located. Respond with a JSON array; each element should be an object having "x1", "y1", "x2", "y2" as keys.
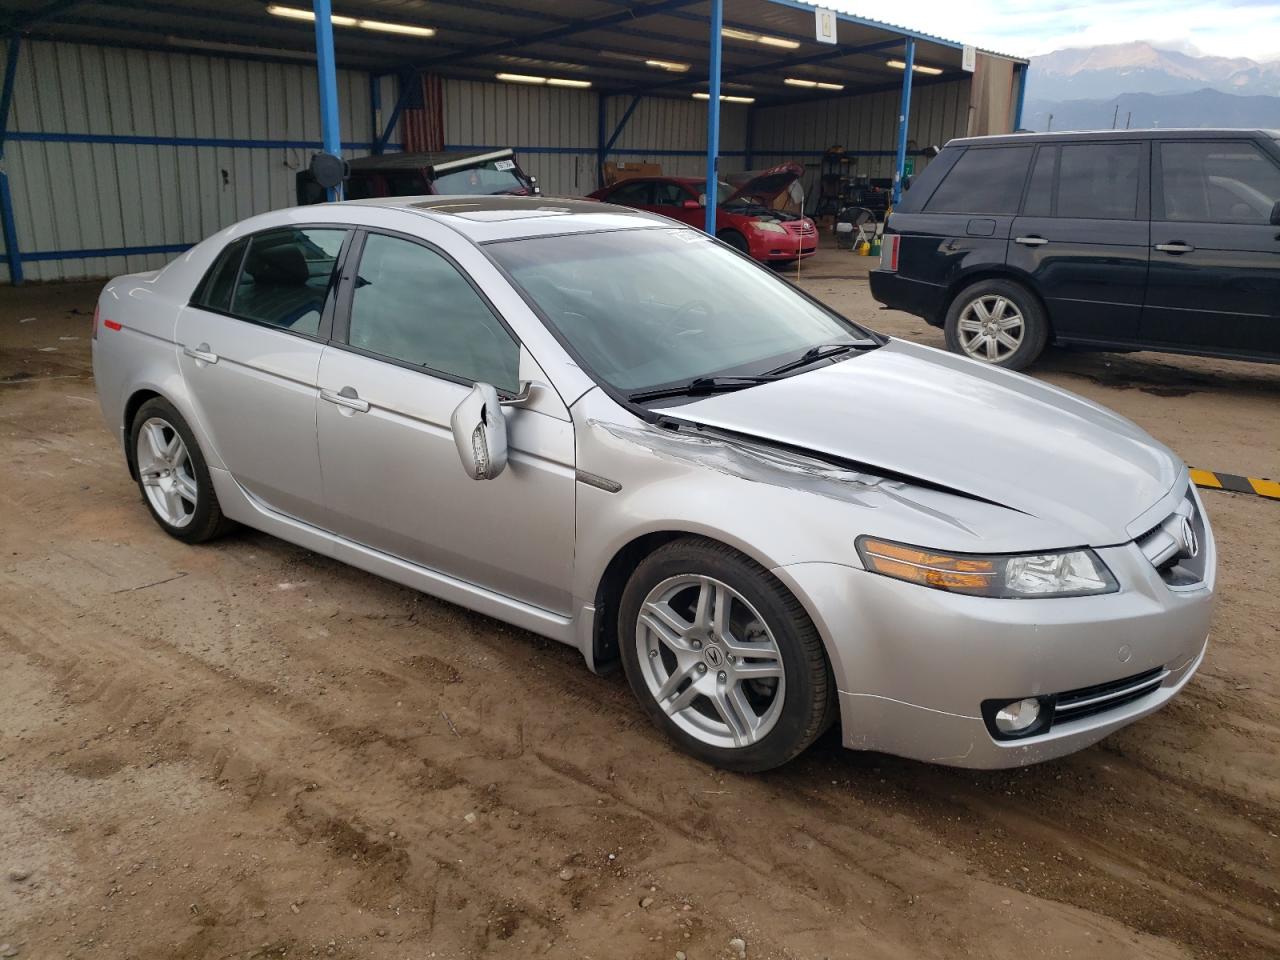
[{"x1": 178, "y1": 227, "x2": 349, "y2": 522}]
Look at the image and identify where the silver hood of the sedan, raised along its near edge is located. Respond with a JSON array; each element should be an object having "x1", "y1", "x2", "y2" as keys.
[{"x1": 669, "y1": 340, "x2": 1183, "y2": 547}]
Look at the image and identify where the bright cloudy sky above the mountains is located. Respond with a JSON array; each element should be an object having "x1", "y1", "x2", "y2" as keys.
[{"x1": 829, "y1": 0, "x2": 1280, "y2": 60}]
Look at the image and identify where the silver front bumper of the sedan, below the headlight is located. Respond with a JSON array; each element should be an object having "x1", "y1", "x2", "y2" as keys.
[{"x1": 773, "y1": 522, "x2": 1216, "y2": 768}]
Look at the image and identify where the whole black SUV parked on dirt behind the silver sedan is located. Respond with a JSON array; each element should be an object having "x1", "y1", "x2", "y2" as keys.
[{"x1": 870, "y1": 129, "x2": 1280, "y2": 370}]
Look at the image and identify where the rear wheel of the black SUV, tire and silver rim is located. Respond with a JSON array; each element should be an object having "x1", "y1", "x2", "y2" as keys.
[{"x1": 945, "y1": 280, "x2": 1048, "y2": 370}]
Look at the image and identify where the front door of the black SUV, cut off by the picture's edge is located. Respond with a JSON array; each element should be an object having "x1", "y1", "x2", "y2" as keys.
[{"x1": 1142, "y1": 137, "x2": 1280, "y2": 357}]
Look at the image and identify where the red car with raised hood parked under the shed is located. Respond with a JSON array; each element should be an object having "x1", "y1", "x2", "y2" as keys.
[{"x1": 589, "y1": 164, "x2": 818, "y2": 262}]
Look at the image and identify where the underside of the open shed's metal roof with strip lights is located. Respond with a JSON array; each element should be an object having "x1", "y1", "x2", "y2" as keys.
[{"x1": 9, "y1": 0, "x2": 1029, "y2": 104}]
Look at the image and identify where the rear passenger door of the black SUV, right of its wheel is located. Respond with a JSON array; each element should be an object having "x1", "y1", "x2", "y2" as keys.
[{"x1": 1007, "y1": 141, "x2": 1151, "y2": 343}]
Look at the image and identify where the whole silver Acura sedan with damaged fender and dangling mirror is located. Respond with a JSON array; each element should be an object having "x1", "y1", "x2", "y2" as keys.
[{"x1": 93, "y1": 197, "x2": 1215, "y2": 771}]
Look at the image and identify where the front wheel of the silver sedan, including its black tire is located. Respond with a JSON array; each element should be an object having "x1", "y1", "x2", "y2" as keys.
[{"x1": 618, "y1": 538, "x2": 836, "y2": 772}]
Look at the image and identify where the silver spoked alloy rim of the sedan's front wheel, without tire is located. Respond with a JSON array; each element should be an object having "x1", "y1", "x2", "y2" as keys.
[{"x1": 636, "y1": 573, "x2": 786, "y2": 748}]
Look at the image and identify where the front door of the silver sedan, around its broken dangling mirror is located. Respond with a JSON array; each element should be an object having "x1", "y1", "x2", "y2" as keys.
[{"x1": 316, "y1": 232, "x2": 575, "y2": 614}]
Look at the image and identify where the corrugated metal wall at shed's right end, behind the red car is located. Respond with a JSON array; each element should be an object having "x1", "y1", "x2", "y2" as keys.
[{"x1": 753, "y1": 79, "x2": 970, "y2": 184}]
